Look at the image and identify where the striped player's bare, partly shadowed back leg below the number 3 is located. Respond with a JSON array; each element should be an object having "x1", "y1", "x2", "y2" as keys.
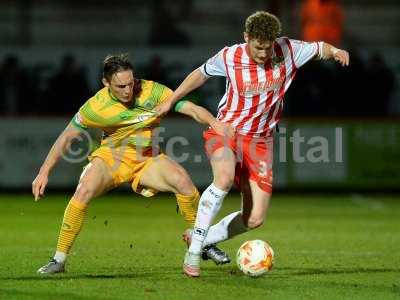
[{"x1": 241, "y1": 179, "x2": 271, "y2": 228}]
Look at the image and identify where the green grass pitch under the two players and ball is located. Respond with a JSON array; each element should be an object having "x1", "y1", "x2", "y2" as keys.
[{"x1": 0, "y1": 194, "x2": 400, "y2": 300}]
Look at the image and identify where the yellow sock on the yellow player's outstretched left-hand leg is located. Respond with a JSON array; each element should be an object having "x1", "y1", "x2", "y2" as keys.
[{"x1": 57, "y1": 198, "x2": 87, "y2": 254}]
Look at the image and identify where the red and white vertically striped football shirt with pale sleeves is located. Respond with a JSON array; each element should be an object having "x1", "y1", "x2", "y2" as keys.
[{"x1": 199, "y1": 37, "x2": 322, "y2": 137}]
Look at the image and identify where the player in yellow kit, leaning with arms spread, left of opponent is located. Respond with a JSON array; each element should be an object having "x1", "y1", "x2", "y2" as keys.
[{"x1": 32, "y1": 54, "x2": 233, "y2": 274}]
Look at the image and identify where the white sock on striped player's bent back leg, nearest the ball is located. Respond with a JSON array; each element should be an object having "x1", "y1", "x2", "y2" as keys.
[{"x1": 203, "y1": 211, "x2": 249, "y2": 246}]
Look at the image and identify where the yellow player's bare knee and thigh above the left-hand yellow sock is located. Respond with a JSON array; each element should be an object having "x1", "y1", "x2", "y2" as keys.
[{"x1": 74, "y1": 157, "x2": 114, "y2": 203}]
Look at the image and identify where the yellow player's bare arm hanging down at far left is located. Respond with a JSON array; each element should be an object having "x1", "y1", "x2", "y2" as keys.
[{"x1": 32, "y1": 124, "x2": 81, "y2": 201}]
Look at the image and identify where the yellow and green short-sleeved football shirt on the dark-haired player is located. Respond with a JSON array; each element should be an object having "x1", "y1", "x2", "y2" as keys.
[{"x1": 72, "y1": 80, "x2": 172, "y2": 148}]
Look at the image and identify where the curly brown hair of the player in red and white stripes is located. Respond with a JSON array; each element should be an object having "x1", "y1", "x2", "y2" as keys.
[{"x1": 245, "y1": 11, "x2": 281, "y2": 42}]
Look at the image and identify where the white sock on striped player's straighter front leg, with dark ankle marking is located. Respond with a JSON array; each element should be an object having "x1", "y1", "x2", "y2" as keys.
[{"x1": 189, "y1": 184, "x2": 227, "y2": 254}]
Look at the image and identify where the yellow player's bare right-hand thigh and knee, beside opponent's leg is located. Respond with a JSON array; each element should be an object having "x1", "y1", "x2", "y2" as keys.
[{"x1": 139, "y1": 155, "x2": 195, "y2": 195}]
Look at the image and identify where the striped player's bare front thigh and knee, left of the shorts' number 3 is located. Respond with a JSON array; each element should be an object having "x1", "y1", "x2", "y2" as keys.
[{"x1": 210, "y1": 147, "x2": 236, "y2": 190}]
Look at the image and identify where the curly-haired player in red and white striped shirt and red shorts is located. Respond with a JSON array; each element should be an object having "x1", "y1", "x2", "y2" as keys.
[{"x1": 156, "y1": 11, "x2": 349, "y2": 277}]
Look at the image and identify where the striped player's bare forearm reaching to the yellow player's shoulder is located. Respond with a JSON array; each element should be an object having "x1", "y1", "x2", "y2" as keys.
[{"x1": 155, "y1": 69, "x2": 207, "y2": 116}]
